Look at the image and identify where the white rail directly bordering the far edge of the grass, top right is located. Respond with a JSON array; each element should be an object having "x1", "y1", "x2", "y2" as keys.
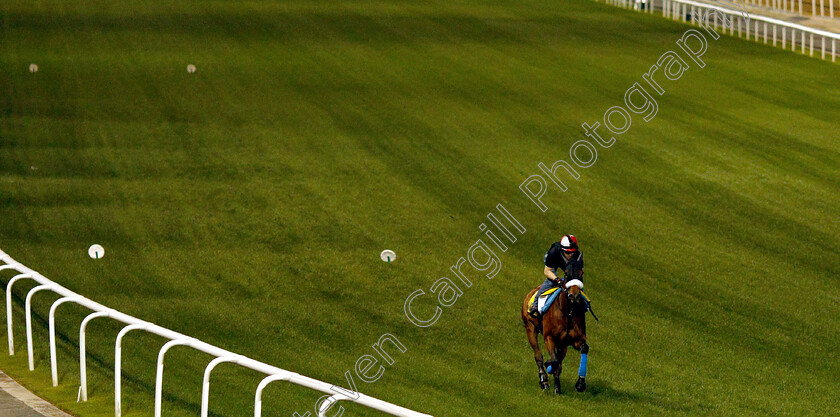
[{"x1": 605, "y1": 0, "x2": 840, "y2": 62}]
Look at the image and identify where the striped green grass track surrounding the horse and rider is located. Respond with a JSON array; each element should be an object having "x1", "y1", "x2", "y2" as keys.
[{"x1": 0, "y1": 0, "x2": 840, "y2": 417}]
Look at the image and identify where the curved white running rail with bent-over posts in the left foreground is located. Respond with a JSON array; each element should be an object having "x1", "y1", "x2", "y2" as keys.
[{"x1": 0, "y1": 250, "x2": 432, "y2": 417}]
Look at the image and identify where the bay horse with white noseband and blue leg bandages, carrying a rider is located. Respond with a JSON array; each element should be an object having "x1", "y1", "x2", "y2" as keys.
[{"x1": 521, "y1": 262, "x2": 589, "y2": 394}]
